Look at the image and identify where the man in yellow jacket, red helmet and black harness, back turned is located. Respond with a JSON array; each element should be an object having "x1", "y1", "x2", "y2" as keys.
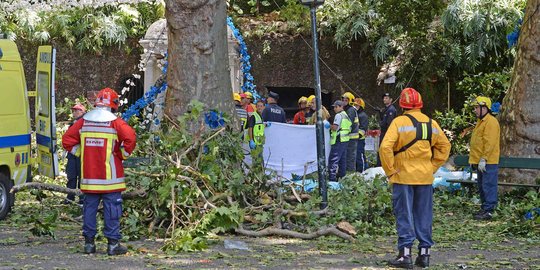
[{"x1": 379, "y1": 88, "x2": 450, "y2": 269}]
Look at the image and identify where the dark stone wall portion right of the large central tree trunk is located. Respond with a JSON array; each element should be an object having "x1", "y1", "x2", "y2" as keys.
[{"x1": 246, "y1": 36, "x2": 447, "y2": 114}]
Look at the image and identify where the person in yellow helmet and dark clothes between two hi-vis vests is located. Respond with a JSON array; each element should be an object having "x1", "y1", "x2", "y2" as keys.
[{"x1": 341, "y1": 92, "x2": 360, "y2": 172}]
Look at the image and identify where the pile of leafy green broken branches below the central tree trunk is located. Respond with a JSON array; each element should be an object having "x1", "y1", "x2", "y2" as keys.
[{"x1": 117, "y1": 102, "x2": 392, "y2": 251}]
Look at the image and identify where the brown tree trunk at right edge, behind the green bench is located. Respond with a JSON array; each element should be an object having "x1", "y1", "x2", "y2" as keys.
[{"x1": 501, "y1": 0, "x2": 540, "y2": 183}]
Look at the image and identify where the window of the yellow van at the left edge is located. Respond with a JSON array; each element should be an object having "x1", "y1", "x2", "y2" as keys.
[{"x1": 0, "y1": 66, "x2": 26, "y2": 116}]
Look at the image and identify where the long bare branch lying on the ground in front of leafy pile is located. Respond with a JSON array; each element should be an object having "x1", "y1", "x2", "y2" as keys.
[{"x1": 235, "y1": 225, "x2": 354, "y2": 242}]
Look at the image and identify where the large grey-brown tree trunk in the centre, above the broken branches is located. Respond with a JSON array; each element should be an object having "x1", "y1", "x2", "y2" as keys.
[{"x1": 165, "y1": 0, "x2": 233, "y2": 118}]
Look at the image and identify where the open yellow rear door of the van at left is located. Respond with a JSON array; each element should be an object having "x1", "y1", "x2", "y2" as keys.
[{"x1": 36, "y1": 46, "x2": 58, "y2": 178}]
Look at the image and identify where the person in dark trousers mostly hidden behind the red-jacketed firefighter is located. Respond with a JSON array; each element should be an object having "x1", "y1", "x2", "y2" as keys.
[{"x1": 64, "y1": 103, "x2": 86, "y2": 204}]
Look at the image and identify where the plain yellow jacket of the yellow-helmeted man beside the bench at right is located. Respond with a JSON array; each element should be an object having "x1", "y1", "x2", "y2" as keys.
[{"x1": 469, "y1": 114, "x2": 501, "y2": 164}]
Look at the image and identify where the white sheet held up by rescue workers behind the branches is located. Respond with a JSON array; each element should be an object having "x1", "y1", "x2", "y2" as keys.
[{"x1": 244, "y1": 122, "x2": 330, "y2": 179}]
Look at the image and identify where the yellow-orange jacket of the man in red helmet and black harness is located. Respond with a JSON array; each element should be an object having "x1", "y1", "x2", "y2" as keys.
[{"x1": 379, "y1": 109, "x2": 450, "y2": 185}]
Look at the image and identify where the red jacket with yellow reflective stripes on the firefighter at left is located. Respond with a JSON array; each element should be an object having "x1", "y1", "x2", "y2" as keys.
[{"x1": 62, "y1": 118, "x2": 136, "y2": 193}]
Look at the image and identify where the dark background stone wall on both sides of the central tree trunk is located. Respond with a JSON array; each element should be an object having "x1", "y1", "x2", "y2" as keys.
[{"x1": 18, "y1": 37, "x2": 446, "y2": 118}]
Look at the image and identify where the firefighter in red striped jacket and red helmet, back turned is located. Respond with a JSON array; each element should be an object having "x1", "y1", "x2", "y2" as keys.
[{"x1": 62, "y1": 88, "x2": 136, "y2": 255}]
